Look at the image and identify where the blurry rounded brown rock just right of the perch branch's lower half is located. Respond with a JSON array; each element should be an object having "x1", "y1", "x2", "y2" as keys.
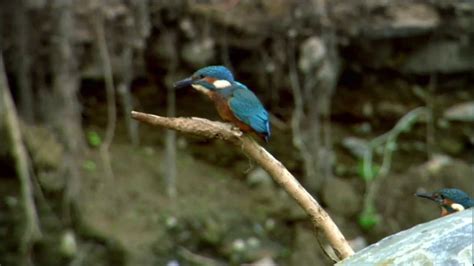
[{"x1": 323, "y1": 177, "x2": 361, "y2": 216}]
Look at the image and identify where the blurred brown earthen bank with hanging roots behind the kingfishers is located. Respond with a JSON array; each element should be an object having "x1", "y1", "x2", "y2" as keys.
[{"x1": 0, "y1": 0, "x2": 474, "y2": 266}]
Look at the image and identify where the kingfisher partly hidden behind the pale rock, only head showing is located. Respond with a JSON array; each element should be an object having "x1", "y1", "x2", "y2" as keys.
[{"x1": 415, "y1": 188, "x2": 474, "y2": 216}]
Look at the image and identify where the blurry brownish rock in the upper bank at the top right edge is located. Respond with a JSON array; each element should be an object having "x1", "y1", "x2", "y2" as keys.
[{"x1": 402, "y1": 40, "x2": 474, "y2": 74}]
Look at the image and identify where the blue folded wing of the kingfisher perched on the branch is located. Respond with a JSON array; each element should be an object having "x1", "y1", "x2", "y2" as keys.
[{"x1": 229, "y1": 87, "x2": 270, "y2": 136}]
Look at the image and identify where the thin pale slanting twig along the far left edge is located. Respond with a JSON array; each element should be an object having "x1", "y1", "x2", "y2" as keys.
[{"x1": 0, "y1": 54, "x2": 41, "y2": 251}]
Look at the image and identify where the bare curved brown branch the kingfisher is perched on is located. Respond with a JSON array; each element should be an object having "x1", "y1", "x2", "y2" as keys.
[{"x1": 132, "y1": 111, "x2": 354, "y2": 259}]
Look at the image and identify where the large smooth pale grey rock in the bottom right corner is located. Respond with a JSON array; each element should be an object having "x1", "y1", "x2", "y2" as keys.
[{"x1": 336, "y1": 208, "x2": 474, "y2": 265}]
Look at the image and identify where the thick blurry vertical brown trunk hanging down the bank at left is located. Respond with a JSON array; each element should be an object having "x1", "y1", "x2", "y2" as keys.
[{"x1": 50, "y1": 0, "x2": 85, "y2": 208}]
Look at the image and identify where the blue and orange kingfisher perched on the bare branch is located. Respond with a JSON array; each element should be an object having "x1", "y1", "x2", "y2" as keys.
[{"x1": 174, "y1": 66, "x2": 271, "y2": 142}]
